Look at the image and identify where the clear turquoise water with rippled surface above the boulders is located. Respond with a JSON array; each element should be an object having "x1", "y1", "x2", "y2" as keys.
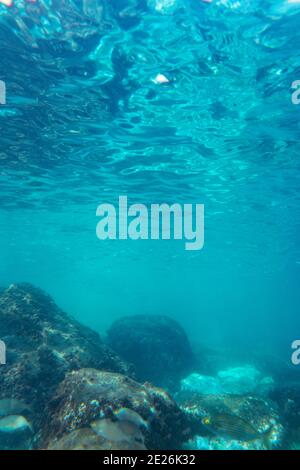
[{"x1": 0, "y1": 0, "x2": 300, "y2": 450}]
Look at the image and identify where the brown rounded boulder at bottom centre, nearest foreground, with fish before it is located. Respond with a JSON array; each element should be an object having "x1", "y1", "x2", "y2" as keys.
[{"x1": 43, "y1": 369, "x2": 193, "y2": 449}]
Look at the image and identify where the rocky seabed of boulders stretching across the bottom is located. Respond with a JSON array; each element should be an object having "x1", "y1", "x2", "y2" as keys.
[{"x1": 0, "y1": 284, "x2": 300, "y2": 450}]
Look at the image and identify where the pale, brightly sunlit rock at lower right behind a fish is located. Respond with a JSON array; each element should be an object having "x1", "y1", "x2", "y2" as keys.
[{"x1": 176, "y1": 365, "x2": 284, "y2": 450}]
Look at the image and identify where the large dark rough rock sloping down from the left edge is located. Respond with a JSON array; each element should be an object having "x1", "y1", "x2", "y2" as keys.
[{"x1": 0, "y1": 284, "x2": 129, "y2": 428}]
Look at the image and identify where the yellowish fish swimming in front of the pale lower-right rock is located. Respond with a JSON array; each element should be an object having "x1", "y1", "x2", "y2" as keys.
[{"x1": 202, "y1": 413, "x2": 273, "y2": 448}]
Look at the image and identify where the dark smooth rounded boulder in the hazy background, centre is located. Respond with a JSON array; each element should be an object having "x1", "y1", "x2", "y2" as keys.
[{"x1": 107, "y1": 315, "x2": 195, "y2": 388}]
